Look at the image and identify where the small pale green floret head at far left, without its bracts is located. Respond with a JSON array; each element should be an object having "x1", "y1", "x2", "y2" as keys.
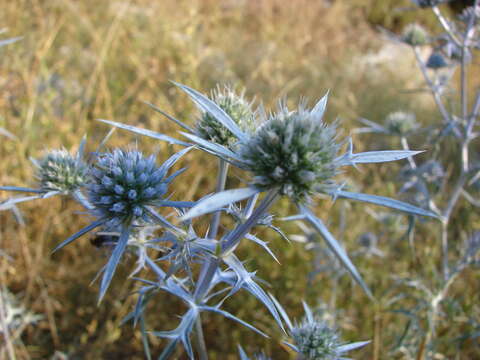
[{"x1": 35, "y1": 149, "x2": 87, "y2": 192}]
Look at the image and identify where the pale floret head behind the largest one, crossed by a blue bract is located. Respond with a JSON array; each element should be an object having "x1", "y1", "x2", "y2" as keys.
[{"x1": 196, "y1": 86, "x2": 255, "y2": 147}]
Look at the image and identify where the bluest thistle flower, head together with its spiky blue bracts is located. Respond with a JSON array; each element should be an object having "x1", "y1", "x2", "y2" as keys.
[{"x1": 50, "y1": 148, "x2": 191, "y2": 300}]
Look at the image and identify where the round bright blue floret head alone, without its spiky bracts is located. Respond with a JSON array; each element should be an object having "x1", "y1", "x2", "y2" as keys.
[{"x1": 88, "y1": 149, "x2": 168, "y2": 223}]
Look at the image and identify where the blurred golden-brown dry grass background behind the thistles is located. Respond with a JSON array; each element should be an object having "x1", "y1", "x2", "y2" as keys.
[{"x1": 0, "y1": 0, "x2": 480, "y2": 359}]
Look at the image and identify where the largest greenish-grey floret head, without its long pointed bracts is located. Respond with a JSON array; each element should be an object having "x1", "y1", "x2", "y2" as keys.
[{"x1": 240, "y1": 101, "x2": 340, "y2": 201}]
